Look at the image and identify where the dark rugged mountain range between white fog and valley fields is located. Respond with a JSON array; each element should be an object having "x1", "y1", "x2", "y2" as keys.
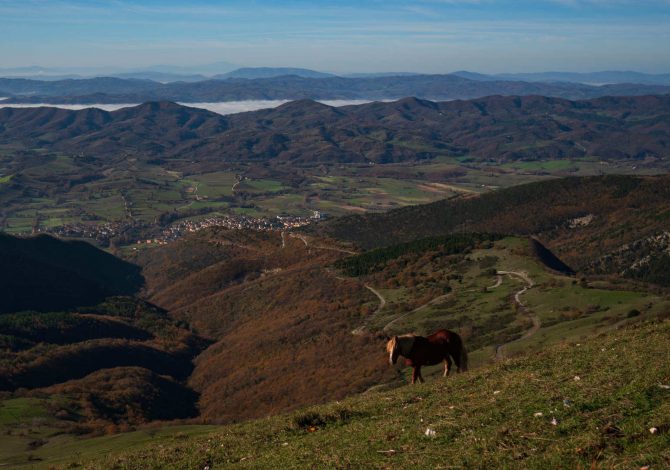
[{"x1": 0, "y1": 96, "x2": 670, "y2": 168}]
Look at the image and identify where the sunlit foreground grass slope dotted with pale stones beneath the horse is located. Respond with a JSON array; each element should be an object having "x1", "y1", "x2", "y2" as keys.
[{"x1": 21, "y1": 320, "x2": 670, "y2": 469}]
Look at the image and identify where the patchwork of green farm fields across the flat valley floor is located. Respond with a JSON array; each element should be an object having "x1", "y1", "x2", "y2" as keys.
[{"x1": 0, "y1": 149, "x2": 662, "y2": 239}]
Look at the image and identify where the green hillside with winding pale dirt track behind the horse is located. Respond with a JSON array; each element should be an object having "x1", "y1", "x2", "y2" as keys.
[{"x1": 338, "y1": 234, "x2": 670, "y2": 366}]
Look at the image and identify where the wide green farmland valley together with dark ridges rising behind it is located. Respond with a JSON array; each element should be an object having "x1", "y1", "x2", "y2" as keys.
[{"x1": 0, "y1": 97, "x2": 668, "y2": 246}]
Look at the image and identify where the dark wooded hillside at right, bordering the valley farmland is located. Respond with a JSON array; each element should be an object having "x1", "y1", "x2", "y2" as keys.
[{"x1": 316, "y1": 176, "x2": 670, "y2": 273}]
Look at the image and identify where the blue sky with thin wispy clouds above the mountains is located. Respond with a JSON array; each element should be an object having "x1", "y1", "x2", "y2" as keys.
[{"x1": 0, "y1": 0, "x2": 670, "y2": 73}]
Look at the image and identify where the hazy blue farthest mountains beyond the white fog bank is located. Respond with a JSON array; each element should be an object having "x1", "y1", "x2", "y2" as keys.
[{"x1": 0, "y1": 69, "x2": 670, "y2": 104}]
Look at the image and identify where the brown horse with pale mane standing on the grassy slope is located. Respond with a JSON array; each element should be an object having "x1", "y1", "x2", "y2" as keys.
[{"x1": 386, "y1": 330, "x2": 468, "y2": 383}]
